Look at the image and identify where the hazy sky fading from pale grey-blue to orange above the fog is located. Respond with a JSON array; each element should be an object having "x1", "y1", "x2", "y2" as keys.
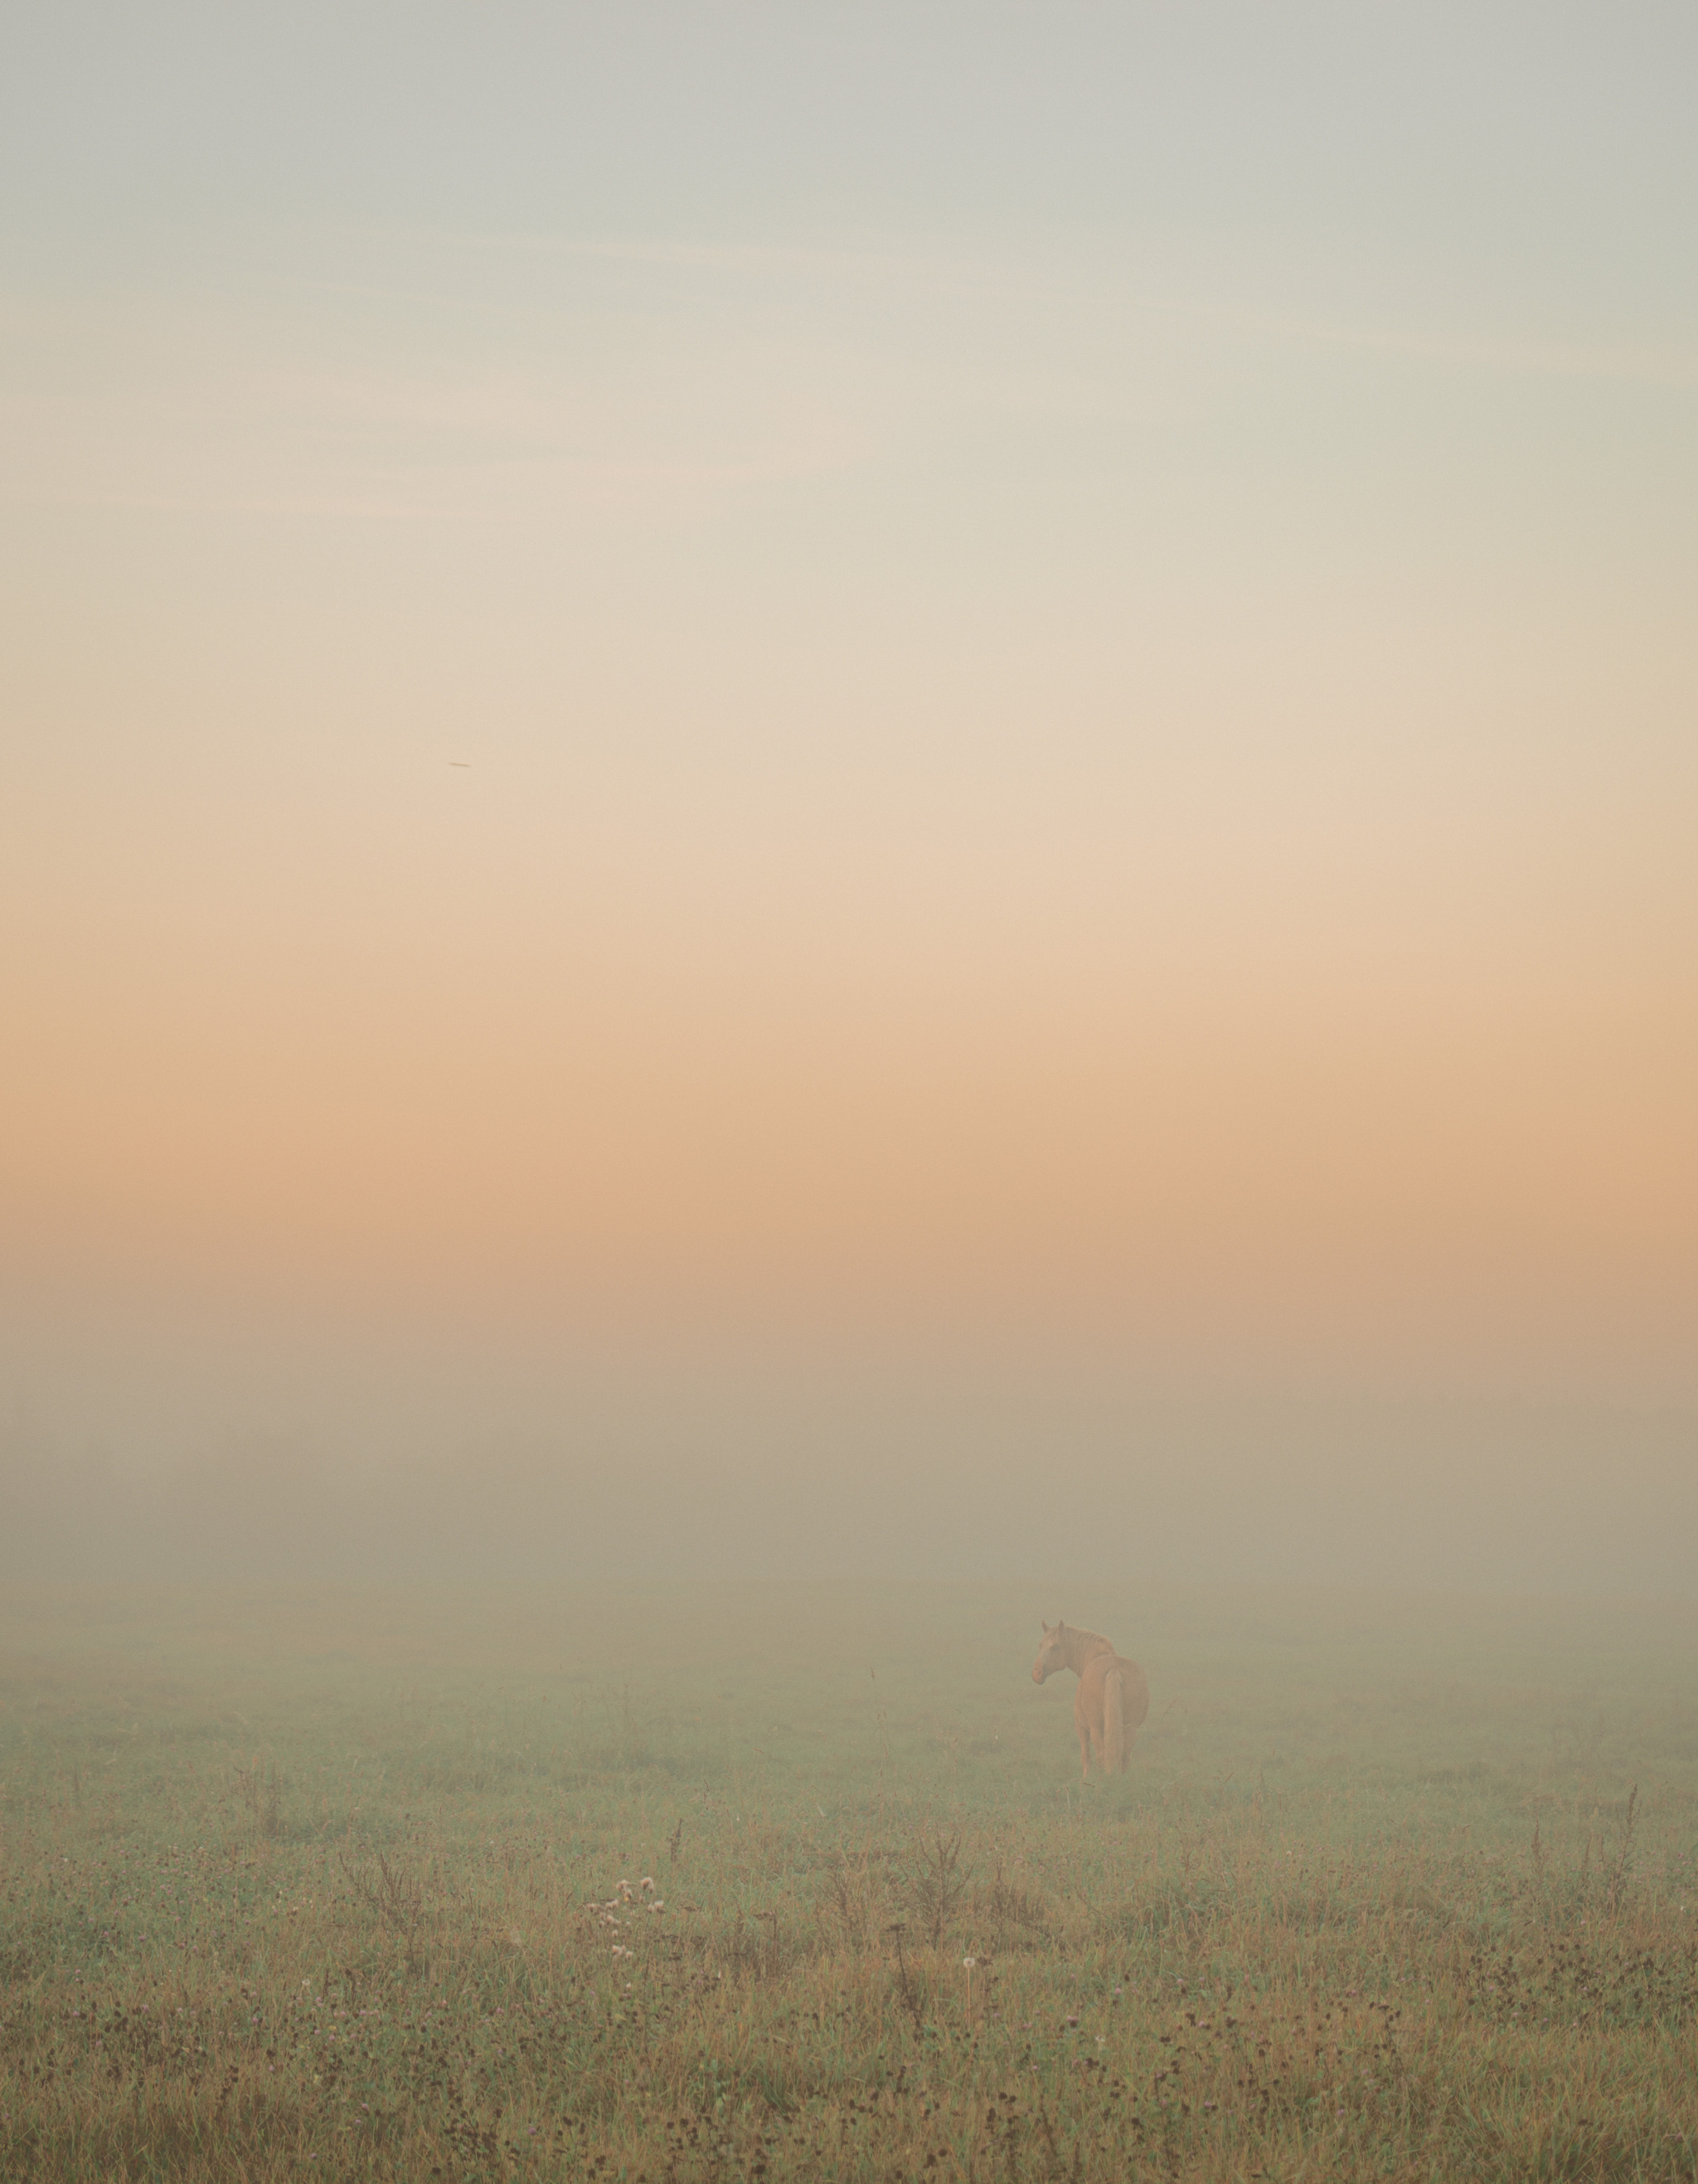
[{"x1": 0, "y1": 0, "x2": 1698, "y2": 1566}]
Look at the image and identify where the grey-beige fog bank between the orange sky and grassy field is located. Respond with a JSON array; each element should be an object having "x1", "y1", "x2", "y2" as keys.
[{"x1": 0, "y1": 1310, "x2": 1698, "y2": 1608}]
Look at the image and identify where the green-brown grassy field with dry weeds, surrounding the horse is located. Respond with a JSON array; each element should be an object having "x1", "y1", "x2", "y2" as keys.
[{"x1": 0, "y1": 1585, "x2": 1698, "y2": 2184}]
